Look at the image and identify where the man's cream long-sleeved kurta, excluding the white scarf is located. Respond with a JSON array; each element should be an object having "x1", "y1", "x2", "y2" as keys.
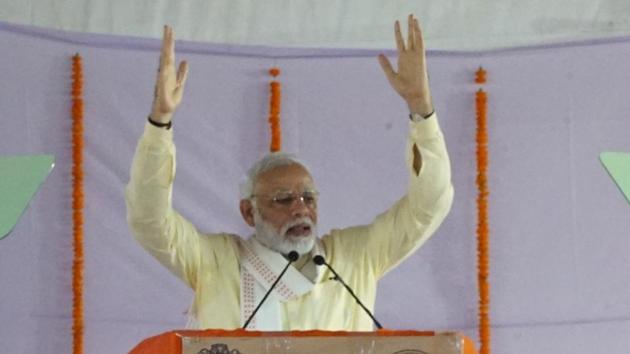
[{"x1": 126, "y1": 116, "x2": 453, "y2": 331}]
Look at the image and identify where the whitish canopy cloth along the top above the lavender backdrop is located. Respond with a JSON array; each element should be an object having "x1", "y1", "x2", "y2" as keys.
[{"x1": 0, "y1": 0, "x2": 630, "y2": 51}]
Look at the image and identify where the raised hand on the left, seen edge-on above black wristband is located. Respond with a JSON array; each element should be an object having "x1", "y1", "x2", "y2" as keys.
[{"x1": 151, "y1": 25, "x2": 188, "y2": 123}]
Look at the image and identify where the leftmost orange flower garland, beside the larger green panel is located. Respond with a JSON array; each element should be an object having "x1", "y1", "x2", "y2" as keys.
[{"x1": 72, "y1": 54, "x2": 84, "y2": 354}]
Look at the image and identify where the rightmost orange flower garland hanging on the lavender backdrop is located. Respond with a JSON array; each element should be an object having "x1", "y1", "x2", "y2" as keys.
[{"x1": 475, "y1": 67, "x2": 490, "y2": 354}]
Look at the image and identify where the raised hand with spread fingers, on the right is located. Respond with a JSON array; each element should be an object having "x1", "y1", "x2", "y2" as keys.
[{"x1": 378, "y1": 15, "x2": 433, "y2": 116}]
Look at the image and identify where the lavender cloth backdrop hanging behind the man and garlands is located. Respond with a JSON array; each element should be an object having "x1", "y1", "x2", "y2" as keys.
[{"x1": 0, "y1": 24, "x2": 630, "y2": 354}]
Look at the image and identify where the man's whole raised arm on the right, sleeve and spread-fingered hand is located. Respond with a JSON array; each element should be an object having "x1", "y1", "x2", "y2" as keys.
[{"x1": 331, "y1": 16, "x2": 453, "y2": 277}]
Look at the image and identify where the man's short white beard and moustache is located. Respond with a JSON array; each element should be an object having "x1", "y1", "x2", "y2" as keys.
[{"x1": 254, "y1": 209, "x2": 317, "y2": 255}]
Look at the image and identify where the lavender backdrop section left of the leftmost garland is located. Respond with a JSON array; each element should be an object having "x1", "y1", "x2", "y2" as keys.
[{"x1": 0, "y1": 25, "x2": 77, "y2": 353}]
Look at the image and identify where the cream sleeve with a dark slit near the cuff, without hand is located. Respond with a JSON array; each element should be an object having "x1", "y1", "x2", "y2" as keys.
[{"x1": 330, "y1": 115, "x2": 453, "y2": 279}]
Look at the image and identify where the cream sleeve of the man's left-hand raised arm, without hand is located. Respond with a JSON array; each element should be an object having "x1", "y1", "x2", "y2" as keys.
[{"x1": 125, "y1": 123, "x2": 200, "y2": 288}]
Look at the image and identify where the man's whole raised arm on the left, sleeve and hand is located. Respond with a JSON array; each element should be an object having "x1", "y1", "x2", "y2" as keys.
[{"x1": 125, "y1": 26, "x2": 199, "y2": 287}]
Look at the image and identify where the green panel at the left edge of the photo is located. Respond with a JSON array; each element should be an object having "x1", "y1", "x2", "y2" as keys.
[{"x1": 0, "y1": 155, "x2": 55, "y2": 239}]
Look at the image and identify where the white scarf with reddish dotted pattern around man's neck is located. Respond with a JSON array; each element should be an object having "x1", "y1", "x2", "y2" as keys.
[{"x1": 239, "y1": 237, "x2": 325, "y2": 331}]
